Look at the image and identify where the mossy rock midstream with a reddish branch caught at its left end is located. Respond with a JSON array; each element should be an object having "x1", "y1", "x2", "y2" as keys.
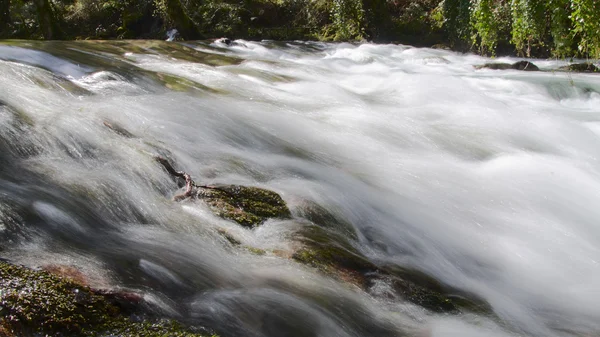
[{"x1": 196, "y1": 185, "x2": 291, "y2": 227}]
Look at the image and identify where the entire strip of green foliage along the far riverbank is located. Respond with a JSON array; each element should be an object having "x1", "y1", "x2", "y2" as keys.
[{"x1": 0, "y1": 0, "x2": 600, "y2": 58}]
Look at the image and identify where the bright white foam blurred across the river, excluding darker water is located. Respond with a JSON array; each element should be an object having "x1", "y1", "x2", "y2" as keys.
[{"x1": 0, "y1": 41, "x2": 600, "y2": 336}]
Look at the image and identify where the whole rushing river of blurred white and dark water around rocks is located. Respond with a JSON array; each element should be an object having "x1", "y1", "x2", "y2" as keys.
[{"x1": 0, "y1": 41, "x2": 600, "y2": 337}]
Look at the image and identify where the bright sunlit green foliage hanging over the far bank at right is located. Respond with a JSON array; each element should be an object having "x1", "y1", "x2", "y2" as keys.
[{"x1": 468, "y1": 0, "x2": 600, "y2": 58}]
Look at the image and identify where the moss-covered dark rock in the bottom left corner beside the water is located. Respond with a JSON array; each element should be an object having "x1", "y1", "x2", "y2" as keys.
[{"x1": 0, "y1": 261, "x2": 214, "y2": 337}]
